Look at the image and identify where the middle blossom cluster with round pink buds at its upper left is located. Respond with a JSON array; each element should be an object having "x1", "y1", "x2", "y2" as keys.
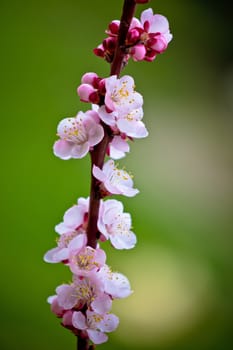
[{"x1": 54, "y1": 72, "x2": 148, "y2": 159}]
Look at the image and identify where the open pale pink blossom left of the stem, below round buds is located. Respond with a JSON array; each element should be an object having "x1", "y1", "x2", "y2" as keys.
[{"x1": 53, "y1": 111, "x2": 104, "y2": 160}]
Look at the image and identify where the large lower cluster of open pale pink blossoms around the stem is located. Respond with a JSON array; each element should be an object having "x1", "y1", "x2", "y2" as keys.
[{"x1": 44, "y1": 198, "x2": 132, "y2": 344}]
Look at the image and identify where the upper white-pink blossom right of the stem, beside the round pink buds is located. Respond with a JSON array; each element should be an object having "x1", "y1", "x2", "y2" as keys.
[{"x1": 105, "y1": 75, "x2": 143, "y2": 113}]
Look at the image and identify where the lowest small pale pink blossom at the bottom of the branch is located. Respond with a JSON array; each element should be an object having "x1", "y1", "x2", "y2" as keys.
[{"x1": 72, "y1": 310, "x2": 119, "y2": 344}]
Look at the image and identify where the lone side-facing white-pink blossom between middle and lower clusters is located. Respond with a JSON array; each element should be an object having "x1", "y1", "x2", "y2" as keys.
[{"x1": 93, "y1": 159, "x2": 139, "y2": 197}]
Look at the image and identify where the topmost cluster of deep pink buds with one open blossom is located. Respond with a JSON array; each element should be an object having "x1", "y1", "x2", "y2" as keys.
[{"x1": 94, "y1": 7, "x2": 172, "y2": 64}]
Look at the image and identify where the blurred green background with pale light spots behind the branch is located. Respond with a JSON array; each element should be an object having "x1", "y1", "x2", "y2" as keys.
[{"x1": 0, "y1": 0, "x2": 233, "y2": 350}]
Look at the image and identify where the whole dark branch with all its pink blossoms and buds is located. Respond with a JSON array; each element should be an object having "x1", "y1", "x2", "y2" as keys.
[{"x1": 44, "y1": 0, "x2": 172, "y2": 350}]
